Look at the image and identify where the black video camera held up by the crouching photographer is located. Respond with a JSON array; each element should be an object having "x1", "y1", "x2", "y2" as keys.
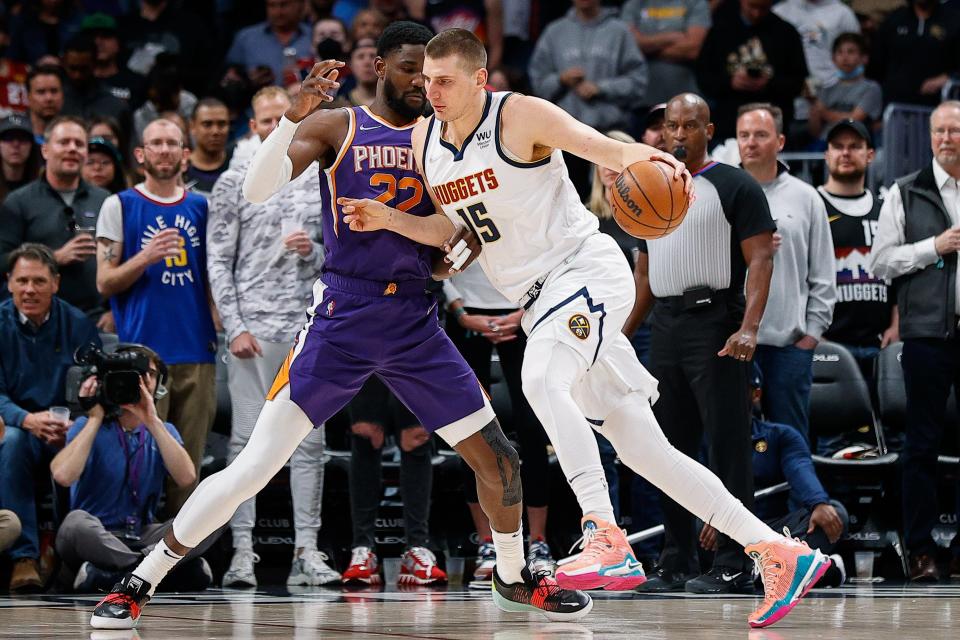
[{"x1": 74, "y1": 344, "x2": 166, "y2": 415}]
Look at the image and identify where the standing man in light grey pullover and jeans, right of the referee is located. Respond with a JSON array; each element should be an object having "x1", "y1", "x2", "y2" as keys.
[{"x1": 737, "y1": 103, "x2": 837, "y2": 440}]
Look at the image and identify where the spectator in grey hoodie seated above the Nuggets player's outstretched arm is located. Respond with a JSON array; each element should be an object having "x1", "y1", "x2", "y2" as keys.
[{"x1": 529, "y1": 0, "x2": 647, "y2": 199}]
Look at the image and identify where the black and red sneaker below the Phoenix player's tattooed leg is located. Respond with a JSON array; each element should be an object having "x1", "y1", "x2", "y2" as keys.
[{"x1": 493, "y1": 567, "x2": 593, "y2": 622}]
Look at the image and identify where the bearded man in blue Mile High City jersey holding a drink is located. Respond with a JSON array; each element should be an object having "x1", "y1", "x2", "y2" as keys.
[{"x1": 97, "y1": 119, "x2": 217, "y2": 514}]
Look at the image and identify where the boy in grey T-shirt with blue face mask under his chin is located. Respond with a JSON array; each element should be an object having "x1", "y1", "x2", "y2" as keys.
[{"x1": 810, "y1": 33, "x2": 883, "y2": 141}]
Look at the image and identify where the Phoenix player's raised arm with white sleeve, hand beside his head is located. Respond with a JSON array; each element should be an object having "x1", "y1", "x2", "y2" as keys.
[{"x1": 243, "y1": 60, "x2": 343, "y2": 203}]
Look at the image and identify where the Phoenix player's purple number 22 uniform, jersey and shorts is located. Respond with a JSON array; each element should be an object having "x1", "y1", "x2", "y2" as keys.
[{"x1": 267, "y1": 107, "x2": 494, "y2": 444}]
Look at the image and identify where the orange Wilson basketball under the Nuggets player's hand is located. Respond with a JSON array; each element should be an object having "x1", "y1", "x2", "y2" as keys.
[{"x1": 610, "y1": 160, "x2": 690, "y2": 240}]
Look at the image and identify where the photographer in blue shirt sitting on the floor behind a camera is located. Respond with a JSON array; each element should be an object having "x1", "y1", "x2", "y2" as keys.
[{"x1": 50, "y1": 345, "x2": 216, "y2": 591}]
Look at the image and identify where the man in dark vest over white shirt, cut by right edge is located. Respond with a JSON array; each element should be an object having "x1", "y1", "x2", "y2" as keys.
[{"x1": 870, "y1": 100, "x2": 960, "y2": 581}]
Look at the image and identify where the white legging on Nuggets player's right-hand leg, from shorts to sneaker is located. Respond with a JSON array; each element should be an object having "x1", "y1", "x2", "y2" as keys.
[{"x1": 600, "y1": 394, "x2": 781, "y2": 547}]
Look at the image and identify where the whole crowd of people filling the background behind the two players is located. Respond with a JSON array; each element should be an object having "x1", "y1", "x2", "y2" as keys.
[{"x1": 0, "y1": 0, "x2": 960, "y2": 592}]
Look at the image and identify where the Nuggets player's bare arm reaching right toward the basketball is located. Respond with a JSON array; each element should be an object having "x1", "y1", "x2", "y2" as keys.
[{"x1": 501, "y1": 95, "x2": 693, "y2": 193}]
